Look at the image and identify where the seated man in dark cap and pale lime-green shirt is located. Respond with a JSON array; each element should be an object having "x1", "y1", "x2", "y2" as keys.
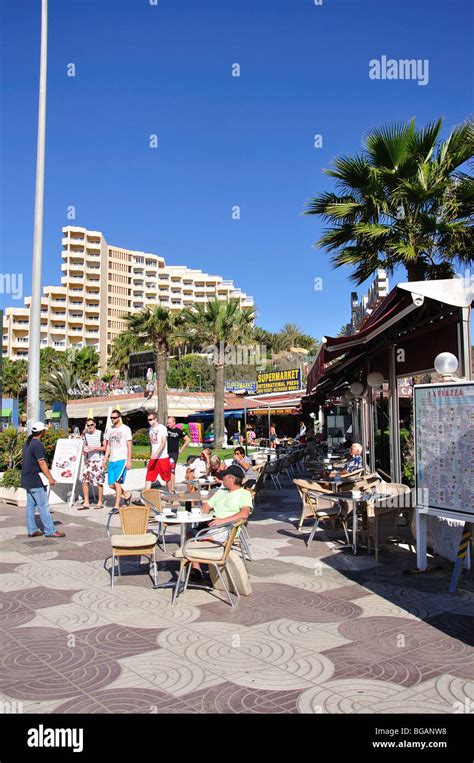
[{"x1": 191, "y1": 466, "x2": 253, "y2": 581}]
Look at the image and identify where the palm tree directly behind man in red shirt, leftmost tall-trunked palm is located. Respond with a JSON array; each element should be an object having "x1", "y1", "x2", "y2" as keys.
[{"x1": 124, "y1": 305, "x2": 183, "y2": 424}]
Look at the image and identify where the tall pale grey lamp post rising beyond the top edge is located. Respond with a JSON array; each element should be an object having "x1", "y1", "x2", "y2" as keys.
[{"x1": 27, "y1": 0, "x2": 48, "y2": 432}]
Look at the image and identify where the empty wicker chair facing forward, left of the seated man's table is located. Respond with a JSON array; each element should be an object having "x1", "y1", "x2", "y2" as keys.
[{"x1": 107, "y1": 504, "x2": 158, "y2": 589}]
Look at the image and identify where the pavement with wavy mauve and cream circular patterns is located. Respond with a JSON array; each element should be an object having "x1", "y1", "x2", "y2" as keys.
[{"x1": 0, "y1": 487, "x2": 474, "y2": 713}]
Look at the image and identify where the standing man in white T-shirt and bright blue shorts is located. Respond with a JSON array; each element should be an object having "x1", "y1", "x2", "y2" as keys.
[{"x1": 104, "y1": 408, "x2": 132, "y2": 509}]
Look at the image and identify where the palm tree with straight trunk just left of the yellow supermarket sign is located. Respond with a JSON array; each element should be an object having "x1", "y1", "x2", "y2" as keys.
[{"x1": 182, "y1": 299, "x2": 256, "y2": 447}]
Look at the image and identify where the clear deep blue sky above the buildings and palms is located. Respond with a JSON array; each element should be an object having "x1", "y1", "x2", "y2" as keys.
[{"x1": 0, "y1": 0, "x2": 473, "y2": 337}]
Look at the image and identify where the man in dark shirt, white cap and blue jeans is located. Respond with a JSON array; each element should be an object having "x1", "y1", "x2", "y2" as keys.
[{"x1": 21, "y1": 421, "x2": 65, "y2": 538}]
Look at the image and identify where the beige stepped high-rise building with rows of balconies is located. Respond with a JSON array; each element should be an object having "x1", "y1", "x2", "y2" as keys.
[{"x1": 2, "y1": 226, "x2": 254, "y2": 368}]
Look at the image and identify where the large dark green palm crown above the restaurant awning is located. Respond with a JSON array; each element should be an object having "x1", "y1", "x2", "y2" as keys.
[{"x1": 305, "y1": 119, "x2": 474, "y2": 284}]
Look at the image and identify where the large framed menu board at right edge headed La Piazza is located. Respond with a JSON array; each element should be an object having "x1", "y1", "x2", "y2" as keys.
[{"x1": 414, "y1": 382, "x2": 474, "y2": 516}]
